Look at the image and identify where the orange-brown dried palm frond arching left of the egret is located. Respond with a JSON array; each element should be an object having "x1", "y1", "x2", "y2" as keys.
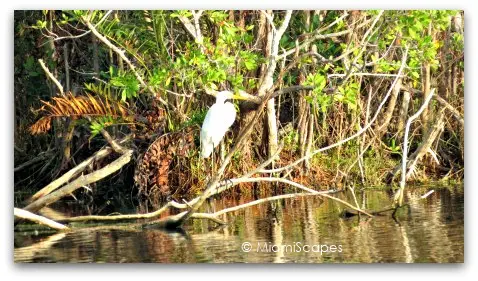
[{"x1": 30, "y1": 93, "x2": 131, "y2": 135}]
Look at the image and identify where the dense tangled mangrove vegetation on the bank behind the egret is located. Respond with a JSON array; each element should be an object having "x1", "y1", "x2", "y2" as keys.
[{"x1": 14, "y1": 10, "x2": 464, "y2": 206}]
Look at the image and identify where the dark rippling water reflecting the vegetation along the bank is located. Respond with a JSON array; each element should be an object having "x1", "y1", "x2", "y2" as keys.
[{"x1": 14, "y1": 187, "x2": 464, "y2": 263}]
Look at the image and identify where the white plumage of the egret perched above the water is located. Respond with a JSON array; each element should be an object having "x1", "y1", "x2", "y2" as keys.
[{"x1": 201, "y1": 91, "x2": 236, "y2": 158}]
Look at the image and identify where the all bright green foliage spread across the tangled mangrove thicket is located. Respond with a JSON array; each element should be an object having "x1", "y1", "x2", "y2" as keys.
[{"x1": 15, "y1": 10, "x2": 464, "y2": 190}]
